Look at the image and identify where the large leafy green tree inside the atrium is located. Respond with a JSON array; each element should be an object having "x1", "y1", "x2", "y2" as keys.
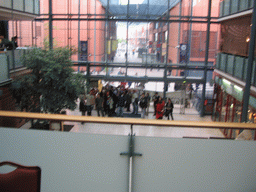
[{"x1": 12, "y1": 48, "x2": 85, "y2": 113}]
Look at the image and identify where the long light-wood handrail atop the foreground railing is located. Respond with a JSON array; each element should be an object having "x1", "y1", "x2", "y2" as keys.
[{"x1": 0, "y1": 111, "x2": 256, "y2": 130}]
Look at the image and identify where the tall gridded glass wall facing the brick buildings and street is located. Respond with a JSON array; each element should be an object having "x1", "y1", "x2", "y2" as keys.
[{"x1": 2, "y1": 0, "x2": 240, "y2": 117}]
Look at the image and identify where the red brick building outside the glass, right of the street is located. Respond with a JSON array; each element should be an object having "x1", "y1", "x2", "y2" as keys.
[{"x1": 149, "y1": 0, "x2": 219, "y2": 82}]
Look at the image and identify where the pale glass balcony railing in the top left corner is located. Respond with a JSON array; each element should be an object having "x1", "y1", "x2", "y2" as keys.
[{"x1": 0, "y1": 0, "x2": 39, "y2": 15}]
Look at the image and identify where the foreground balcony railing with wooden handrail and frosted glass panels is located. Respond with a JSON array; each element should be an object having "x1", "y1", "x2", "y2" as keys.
[{"x1": 0, "y1": 111, "x2": 256, "y2": 192}]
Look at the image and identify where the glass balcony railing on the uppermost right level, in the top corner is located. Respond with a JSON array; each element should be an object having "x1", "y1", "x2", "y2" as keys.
[{"x1": 219, "y1": 0, "x2": 253, "y2": 17}]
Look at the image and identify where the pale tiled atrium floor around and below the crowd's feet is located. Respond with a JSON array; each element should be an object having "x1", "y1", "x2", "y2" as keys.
[{"x1": 62, "y1": 101, "x2": 224, "y2": 138}]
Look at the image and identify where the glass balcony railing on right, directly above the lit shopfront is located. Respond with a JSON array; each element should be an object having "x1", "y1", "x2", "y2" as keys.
[{"x1": 216, "y1": 53, "x2": 256, "y2": 86}]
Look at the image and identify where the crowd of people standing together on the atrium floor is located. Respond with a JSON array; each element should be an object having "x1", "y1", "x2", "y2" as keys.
[{"x1": 79, "y1": 86, "x2": 173, "y2": 120}]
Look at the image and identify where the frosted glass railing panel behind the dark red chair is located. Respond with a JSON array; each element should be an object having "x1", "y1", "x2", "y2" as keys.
[{"x1": 0, "y1": 129, "x2": 129, "y2": 192}]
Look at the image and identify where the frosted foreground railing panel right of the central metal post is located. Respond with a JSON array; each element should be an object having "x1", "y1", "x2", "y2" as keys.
[{"x1": 133, "y1": 136, "x2": 256, "y2": 191}]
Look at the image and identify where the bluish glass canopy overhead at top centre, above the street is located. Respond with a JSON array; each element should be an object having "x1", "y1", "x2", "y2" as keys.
[{"x1": 100, "y1": 0, "x2": 179, "y2": 19}]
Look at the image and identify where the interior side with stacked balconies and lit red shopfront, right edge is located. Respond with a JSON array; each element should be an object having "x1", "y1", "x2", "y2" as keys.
[{"x1": 213, "y1": 0, "x2": 256, "y2": 137}]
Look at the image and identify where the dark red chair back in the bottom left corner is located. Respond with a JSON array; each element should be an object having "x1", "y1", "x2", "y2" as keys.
[{"x1": 0, "y1": 161, "x2": 41, "y2": 192}]
